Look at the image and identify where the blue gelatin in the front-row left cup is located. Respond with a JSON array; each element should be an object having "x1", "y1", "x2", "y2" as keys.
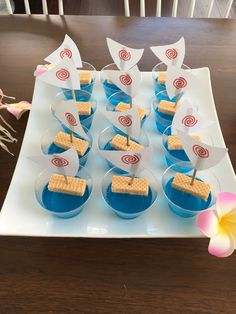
[{"x1": 42, "y1": 184, "x2": 90, "y2": 218}]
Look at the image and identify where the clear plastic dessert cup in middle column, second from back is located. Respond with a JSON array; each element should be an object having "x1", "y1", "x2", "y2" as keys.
[{"x1": 106, "y1": 91, "x2": 151, "y2": 131}]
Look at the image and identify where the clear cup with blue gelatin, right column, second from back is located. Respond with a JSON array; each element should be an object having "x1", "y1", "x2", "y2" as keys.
[{"x1": 153, "y1": 91, "x2": 179, "y2": 133}]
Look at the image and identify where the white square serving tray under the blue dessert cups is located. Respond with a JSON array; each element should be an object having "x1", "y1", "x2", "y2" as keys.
[{"x1": 0, "y1": 68, "x2": 236, "y2": 238}]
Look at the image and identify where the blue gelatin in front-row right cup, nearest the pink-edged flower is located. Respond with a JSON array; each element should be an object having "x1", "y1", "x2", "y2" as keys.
[{"x1": 165, "y1": 178, "x2": 212, "y2": 218}]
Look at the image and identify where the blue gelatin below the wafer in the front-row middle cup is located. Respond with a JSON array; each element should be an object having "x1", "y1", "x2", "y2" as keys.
[{"x1": 105, "y1": 184, "x2": 152, "y2": 219}]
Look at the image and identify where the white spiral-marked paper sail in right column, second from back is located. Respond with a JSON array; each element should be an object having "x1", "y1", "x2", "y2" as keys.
[{"x1": 166, "y1": 66, "x2": 200, "y2": 99}]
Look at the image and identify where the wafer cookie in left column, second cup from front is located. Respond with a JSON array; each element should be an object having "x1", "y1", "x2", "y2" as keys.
[{"x1": 53, "y1": 131, "x2": 89, "y2": 156}]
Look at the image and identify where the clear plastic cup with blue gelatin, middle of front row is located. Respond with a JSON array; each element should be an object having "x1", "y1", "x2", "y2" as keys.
[{"x1": 102, "y1": 168, "x2": 158, "y2": 219}]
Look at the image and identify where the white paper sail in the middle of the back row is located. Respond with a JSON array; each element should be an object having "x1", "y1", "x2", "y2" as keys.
[{"x1": 107, "y1": 38, "x2": 144, "y2": 71}]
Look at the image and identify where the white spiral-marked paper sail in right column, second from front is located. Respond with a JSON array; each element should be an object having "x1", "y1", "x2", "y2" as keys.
[{"x1": 171, "y1": 104, "x2": 214, "y2": 135}]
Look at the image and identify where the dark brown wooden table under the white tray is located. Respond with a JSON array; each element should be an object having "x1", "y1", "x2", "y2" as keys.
[{"x1": 0, "y1": 16, "x2": 236, "y2": 314}]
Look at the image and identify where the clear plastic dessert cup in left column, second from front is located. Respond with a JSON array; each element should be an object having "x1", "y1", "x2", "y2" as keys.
[{"x1": 41, "y1": 126, "x2": 93, "y2": 166}]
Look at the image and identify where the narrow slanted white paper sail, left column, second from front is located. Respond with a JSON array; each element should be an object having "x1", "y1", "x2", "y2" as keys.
[{"x1": 53, "y1": 99, "x2": 89, "y2": 140}]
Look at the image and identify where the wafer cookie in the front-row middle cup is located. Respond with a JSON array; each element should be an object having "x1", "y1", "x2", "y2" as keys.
[{"x1": 111, "y1": 176, "x2": 148, "y2": 196}]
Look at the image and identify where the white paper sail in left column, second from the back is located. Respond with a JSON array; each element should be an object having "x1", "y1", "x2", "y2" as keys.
[{"x1": 38, "y1": 57, "x2": 80, "y2": 90}]
